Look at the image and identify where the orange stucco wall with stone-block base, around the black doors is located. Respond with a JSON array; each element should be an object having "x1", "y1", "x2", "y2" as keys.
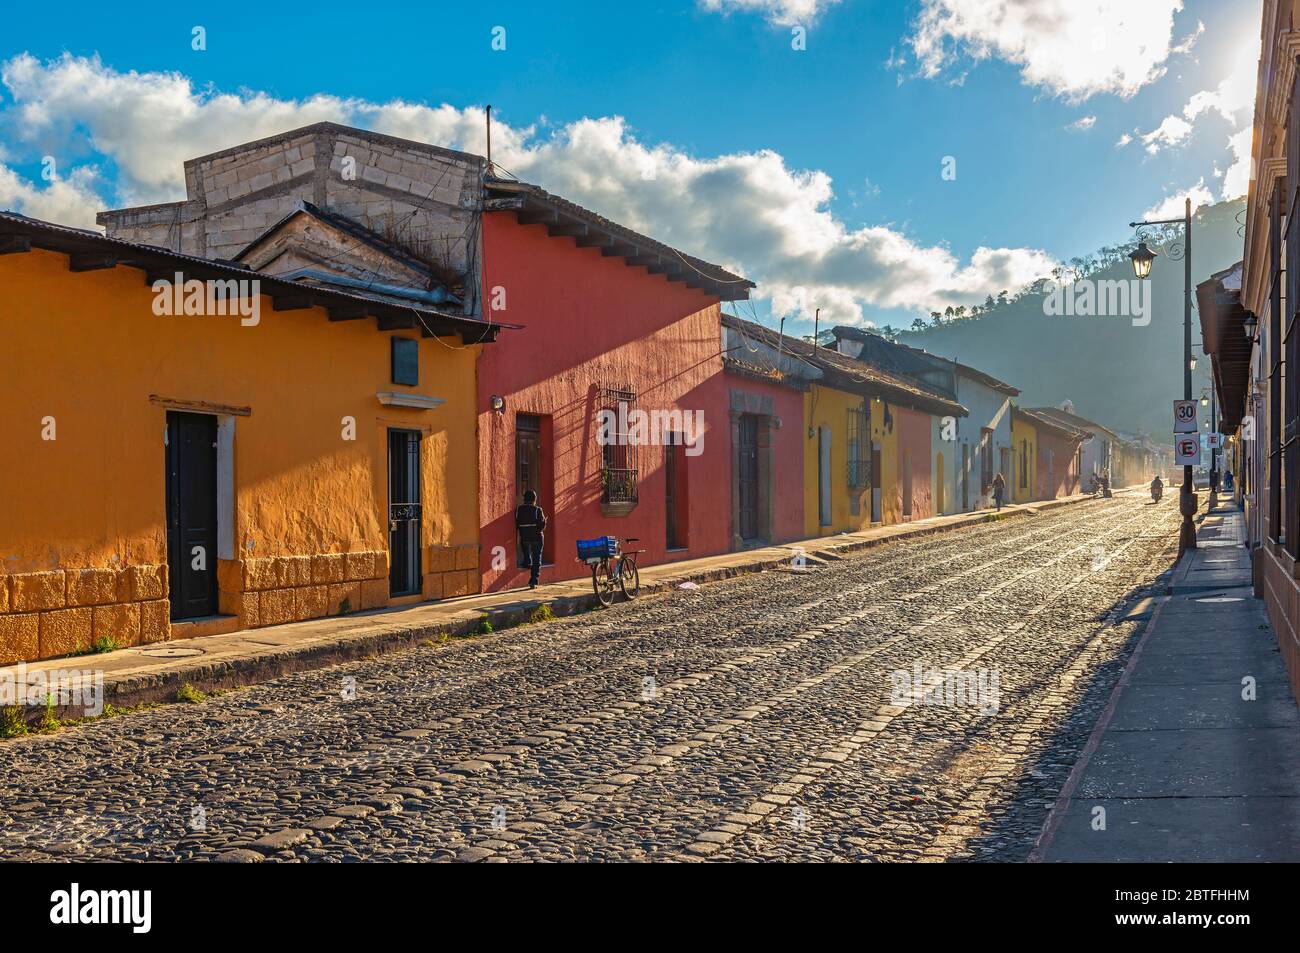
[{"x1": 0, "y1": 251, "x2": 478, "y2": 660}]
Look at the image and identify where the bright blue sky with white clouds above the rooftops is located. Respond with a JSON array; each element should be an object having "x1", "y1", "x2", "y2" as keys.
[{"x1": 0, "y1": 0, "x2": 1260, "y2": 332}]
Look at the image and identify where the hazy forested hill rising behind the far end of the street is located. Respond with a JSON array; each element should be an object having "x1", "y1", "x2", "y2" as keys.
[{"x1": 887, "y1": 199, "x2": 1245, "y2": 439}]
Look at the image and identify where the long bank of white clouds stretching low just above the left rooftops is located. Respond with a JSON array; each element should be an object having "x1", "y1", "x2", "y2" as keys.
[{"x1": 0, "y1": 56, "x2": 1054, "y2": 322}]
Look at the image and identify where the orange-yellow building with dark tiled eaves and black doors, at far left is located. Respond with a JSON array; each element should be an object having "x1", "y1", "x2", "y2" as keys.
[{"x1": 0, "y1": 213, "x2": 499, "y2": 664}]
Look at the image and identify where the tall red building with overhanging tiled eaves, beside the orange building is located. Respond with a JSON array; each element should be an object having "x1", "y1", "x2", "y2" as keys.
[{"x1": 478, "y1": 178, "x2": 754, "y2": 592}]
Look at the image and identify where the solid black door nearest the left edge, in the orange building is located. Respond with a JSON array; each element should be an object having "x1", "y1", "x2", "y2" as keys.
[{"x1": 166, "y1": 411, "x2": 217, "y2": 619}]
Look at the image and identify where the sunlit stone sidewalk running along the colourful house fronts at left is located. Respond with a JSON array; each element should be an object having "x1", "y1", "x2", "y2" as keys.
[{"x1": 0, "y1": 494, "x2": 1091, "y2": 716}]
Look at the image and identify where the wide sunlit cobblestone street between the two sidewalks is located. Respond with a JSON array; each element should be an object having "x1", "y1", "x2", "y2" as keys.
[{"x1": 0, "y1": 494, "x2": 1178, "y2": 861}]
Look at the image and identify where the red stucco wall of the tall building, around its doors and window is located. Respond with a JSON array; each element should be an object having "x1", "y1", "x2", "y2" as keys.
[{"x1": 478, "y1": 212, "x2": 743, "y2": 590}]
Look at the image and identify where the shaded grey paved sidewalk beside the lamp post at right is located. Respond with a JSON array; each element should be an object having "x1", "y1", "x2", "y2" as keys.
[{"x1": 1031, "y1": 502, "x2": 1300, "y2": 862}]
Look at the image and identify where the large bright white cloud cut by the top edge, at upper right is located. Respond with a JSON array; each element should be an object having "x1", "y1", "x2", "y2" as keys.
[{"x1": 909, "y1": 0, "x2": 1196, "y2": 101}]
